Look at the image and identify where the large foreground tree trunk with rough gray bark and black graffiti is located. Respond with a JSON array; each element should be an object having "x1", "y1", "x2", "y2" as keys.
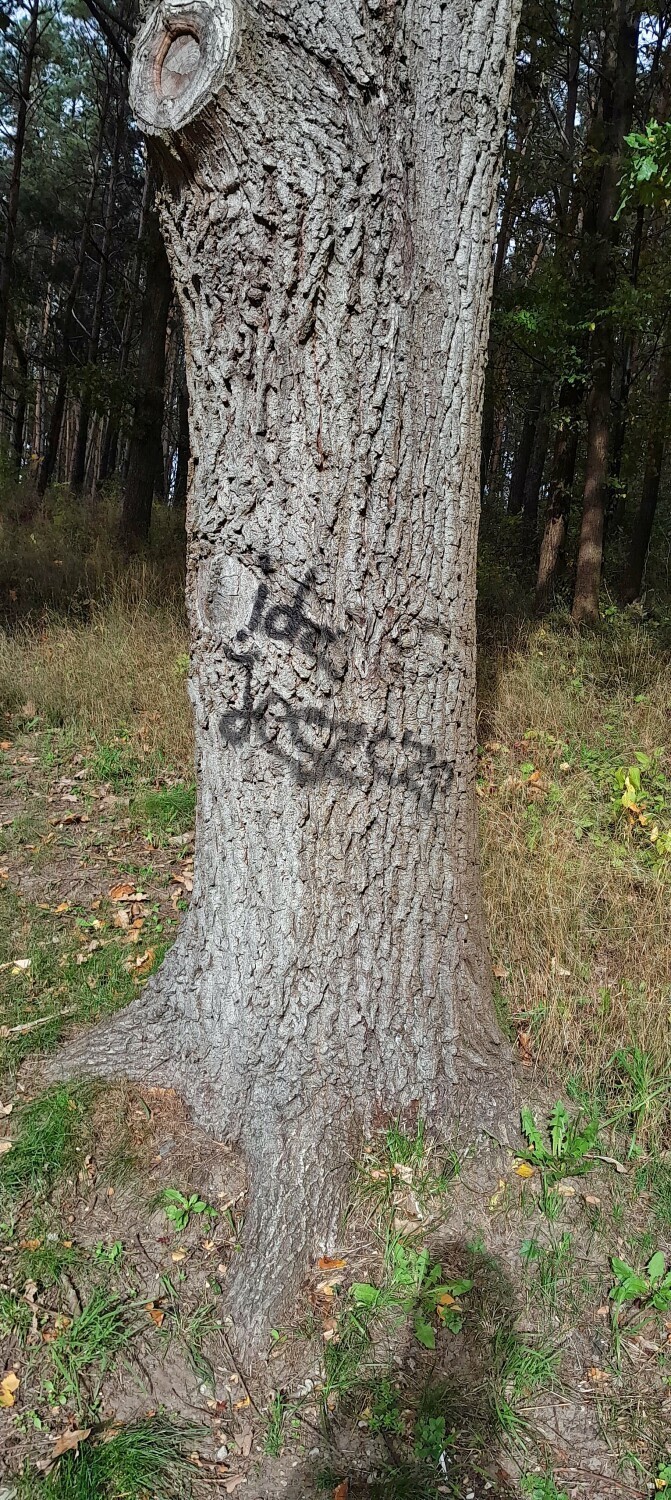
[{"x1": 55, "y1": 0, "x2": 516, "y2": 1350}]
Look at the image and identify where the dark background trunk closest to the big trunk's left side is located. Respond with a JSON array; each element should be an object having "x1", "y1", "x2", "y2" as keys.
[{"x1": 120, "y1": 213, "x2": 173, "y2": 549}]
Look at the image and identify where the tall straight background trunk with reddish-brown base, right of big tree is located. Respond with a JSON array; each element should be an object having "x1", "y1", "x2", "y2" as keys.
[{"x1": 572, "y1": 0, "x2": 641, "y2": 626}]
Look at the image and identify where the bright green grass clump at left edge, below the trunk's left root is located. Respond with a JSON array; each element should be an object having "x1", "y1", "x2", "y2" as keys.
[{"x1": 0, "y1": 1085, "x2": 95, "y2": 1202}]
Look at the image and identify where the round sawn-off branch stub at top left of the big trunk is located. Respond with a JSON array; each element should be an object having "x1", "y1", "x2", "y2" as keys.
[{"x1": 131, "y1": 0, "x2": 236, "y2": 135}]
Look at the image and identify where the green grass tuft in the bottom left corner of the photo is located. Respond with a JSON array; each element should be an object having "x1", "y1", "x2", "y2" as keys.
[{"x1": 17, "y1": 1416, "x2": 203, "y2": 1500}]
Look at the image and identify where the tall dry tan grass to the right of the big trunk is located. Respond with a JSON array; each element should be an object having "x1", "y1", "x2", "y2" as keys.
[{"x1": 480, "y1": 620, "x2": 671, "y2": 1110}]
